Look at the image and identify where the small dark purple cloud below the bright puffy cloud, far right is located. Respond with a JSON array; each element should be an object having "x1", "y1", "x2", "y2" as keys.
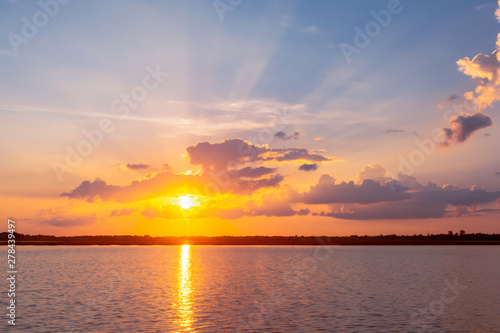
[{"x1": 442, "y1": 112, "x2": 493, "y2": 145}]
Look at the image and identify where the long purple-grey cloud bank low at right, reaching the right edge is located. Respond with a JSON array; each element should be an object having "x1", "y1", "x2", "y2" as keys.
[{"x1": 303, "y1": 170, "x2": 500, "y2": 220}]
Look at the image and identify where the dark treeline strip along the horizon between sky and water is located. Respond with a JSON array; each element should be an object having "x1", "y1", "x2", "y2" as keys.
[{"x1": 0, "y1": 230, "x2": 500, "y2": 245}]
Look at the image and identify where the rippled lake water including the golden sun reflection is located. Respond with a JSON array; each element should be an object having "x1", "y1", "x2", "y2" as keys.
[{"x1": 6, "y1": 245, "x2": 500, "y2": 333}]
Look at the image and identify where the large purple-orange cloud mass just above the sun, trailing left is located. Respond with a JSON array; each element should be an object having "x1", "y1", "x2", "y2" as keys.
[{"x1": 61, "y1": 139, "x2": 308, "y2": 202}]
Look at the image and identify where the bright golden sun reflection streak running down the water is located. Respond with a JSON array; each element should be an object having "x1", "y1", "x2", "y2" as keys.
[{"x1": 177, "y1": 245, "x2": 193, "y2": 330}]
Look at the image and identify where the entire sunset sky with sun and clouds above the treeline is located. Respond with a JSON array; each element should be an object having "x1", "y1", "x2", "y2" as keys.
[{"x1": 0, "y1": 0, "x2": 500, "y2": 236}]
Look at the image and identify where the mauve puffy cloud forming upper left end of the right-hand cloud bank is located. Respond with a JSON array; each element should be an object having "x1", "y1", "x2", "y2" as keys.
[{"x1": 303, "y1": 175, "x2": 412, "y2": 204}]
